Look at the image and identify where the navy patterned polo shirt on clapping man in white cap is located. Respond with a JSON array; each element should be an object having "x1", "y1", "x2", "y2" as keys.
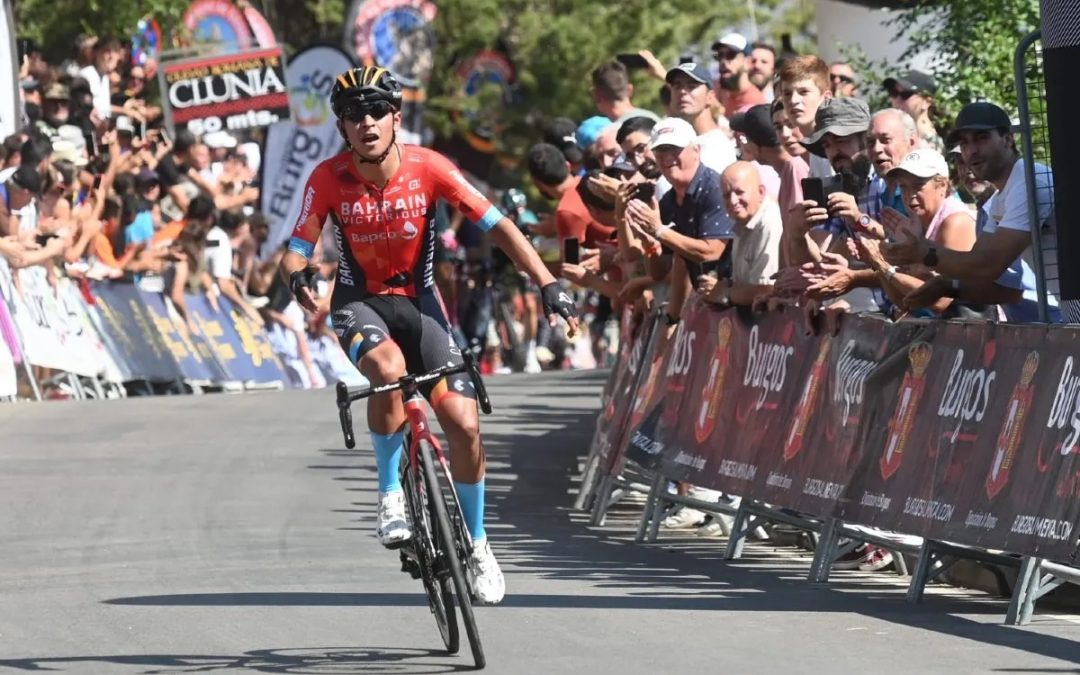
[{"x1": 660, "y1": 164, "x2": 734, "y2": 287}]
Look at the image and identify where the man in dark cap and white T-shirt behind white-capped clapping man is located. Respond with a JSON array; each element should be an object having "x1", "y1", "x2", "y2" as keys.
[{"x1": 665, "y1": 62, "x2": 735, "y2": 176}]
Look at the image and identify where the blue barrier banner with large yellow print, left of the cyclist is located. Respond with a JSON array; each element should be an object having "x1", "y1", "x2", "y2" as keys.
[{"x1": 186, "y1": 294, "x2": 286, "y2": 383}]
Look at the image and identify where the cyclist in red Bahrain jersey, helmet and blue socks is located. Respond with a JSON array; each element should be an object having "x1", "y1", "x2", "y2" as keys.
[{"x1": 281, "y1": 66, "x2": 578, "y2": 604}]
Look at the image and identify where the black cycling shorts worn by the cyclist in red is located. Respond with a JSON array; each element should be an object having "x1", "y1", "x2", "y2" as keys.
[{"x1": 332, "y1": 294, "x2": 476, "y2": 403}]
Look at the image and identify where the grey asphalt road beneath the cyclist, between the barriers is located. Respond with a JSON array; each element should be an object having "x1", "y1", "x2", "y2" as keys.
[{"x1": 0, "y1": 373, "x2": 1080, "y2": 674}]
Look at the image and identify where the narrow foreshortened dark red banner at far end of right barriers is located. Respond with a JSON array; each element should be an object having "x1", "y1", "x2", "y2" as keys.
[{"x1": 590, "y1": 307, "x2": 654, "y2": 473}]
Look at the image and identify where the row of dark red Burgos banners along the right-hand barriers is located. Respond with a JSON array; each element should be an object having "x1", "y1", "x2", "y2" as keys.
[{"x1": 617, "y1": 299, "x2": 1080, "y2": 562}]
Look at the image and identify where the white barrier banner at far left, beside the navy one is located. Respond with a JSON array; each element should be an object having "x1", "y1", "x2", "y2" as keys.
[{"x1": 0, "y1": 259, "x2": 116, "y2": 377}]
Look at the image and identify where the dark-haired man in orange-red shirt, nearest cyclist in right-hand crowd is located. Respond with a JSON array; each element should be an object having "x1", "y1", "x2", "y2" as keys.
[{"x1": 528, "y1": 143, "x2": 615, "y2": 254}]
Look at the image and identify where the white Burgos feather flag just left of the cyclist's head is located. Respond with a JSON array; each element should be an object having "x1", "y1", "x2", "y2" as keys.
[{"x1": 261, "y1": 46, "x2": 352, "y2": 259}]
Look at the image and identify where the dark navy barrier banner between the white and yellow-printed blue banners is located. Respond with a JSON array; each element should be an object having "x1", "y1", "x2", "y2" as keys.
[{"x1": 91, "y1": 282, "x2": 184, "y2": 382}]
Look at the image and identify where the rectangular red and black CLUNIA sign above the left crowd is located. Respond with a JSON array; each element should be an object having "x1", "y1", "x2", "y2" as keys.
[{"x1": 160, "y1": 46, "x2": 291, "y2": 135}]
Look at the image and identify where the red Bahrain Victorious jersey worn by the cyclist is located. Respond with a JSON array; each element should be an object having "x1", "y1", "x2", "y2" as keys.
[{"x1": 288, "y1": 145, "x2": 503, "y2": 297}]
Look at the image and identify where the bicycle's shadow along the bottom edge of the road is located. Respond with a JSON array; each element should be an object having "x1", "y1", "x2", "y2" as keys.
[{"x1": 0, "y1": 647, "x2": 473, "y2": 675}]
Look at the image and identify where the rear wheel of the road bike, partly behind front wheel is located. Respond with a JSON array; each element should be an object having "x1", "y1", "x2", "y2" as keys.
[{"x1": 402, "y1": 436, "x2": 461, "y2": 654}]
